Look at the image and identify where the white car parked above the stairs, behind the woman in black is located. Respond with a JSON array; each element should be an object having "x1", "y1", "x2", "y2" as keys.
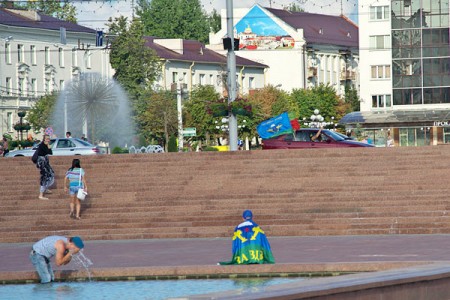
[{"x1": 5, "y1": 138, "x2": 101, "y2": 157}]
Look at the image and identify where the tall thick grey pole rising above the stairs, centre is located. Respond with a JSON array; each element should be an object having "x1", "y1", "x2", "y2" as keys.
[{"x1": 227, "y1": 0, "x2": 238, "y2": 151}]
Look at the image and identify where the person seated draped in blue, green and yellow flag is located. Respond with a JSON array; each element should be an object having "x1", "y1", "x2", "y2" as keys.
[{"x1": 219, "y1": 210, "x2": 275, "y2": 265}]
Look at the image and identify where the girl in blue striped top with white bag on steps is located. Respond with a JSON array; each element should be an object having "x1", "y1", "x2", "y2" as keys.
[{"x1": 64, "y1": 158, "x2": 87, "y2": 220}]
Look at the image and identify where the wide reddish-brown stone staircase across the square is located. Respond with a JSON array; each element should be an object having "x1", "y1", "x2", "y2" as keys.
[{"x1": 0, "y1": 146, "x2": 450, "y2": 243}]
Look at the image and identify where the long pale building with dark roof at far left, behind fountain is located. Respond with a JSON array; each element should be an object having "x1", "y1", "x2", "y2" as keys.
[{"x1": 0, "y1": 8, "x2": 113, "y2": 136}]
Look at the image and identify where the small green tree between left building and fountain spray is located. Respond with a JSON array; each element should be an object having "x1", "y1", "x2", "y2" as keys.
[{"x1": 27, "y1": 92, "x2": 58, "y2": 133}]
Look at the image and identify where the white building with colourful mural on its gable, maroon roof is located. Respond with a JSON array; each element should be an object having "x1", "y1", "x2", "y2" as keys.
[{"x1": 207, "y1": 5, "x2": 359, "y2": 95}]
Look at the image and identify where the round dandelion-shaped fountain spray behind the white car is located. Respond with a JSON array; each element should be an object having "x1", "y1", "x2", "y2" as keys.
[{"x1": 51, "y1": 73, "x2": 134, "y2": 147}]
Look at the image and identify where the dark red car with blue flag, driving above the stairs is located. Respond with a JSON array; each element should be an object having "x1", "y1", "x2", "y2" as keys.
[{"x1": 262, "y1": 128, "x2": 374, "y2": 149}]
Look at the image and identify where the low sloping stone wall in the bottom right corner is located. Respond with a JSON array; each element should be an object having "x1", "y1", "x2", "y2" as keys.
[{"x1": 193, "y1": 262, "x2": 450, "y2": 300}]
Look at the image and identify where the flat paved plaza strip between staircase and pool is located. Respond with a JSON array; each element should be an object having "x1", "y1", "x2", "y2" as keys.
[{"x1": 0, "y1": 235, "x2": 450, "y2": 282}]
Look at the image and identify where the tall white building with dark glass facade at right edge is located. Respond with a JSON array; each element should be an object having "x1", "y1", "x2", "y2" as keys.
[{"x1": 342, "y1": 0, "x2": 450, "y2": 146}]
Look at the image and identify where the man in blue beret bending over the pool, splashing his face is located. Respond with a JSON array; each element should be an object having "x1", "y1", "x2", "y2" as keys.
[{"x1": 30, "y1": 235, "x2": 84, "y2": 283}]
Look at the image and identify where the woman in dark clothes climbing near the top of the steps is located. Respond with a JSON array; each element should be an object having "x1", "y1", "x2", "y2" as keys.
[{"x1": 36, "y1": 134, "x2": 55, "y2": 200}]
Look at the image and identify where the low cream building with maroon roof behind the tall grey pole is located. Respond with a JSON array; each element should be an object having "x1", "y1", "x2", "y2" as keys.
[{"x1": 145, "y1": 37, "x2": 268, "y2": 96}]
